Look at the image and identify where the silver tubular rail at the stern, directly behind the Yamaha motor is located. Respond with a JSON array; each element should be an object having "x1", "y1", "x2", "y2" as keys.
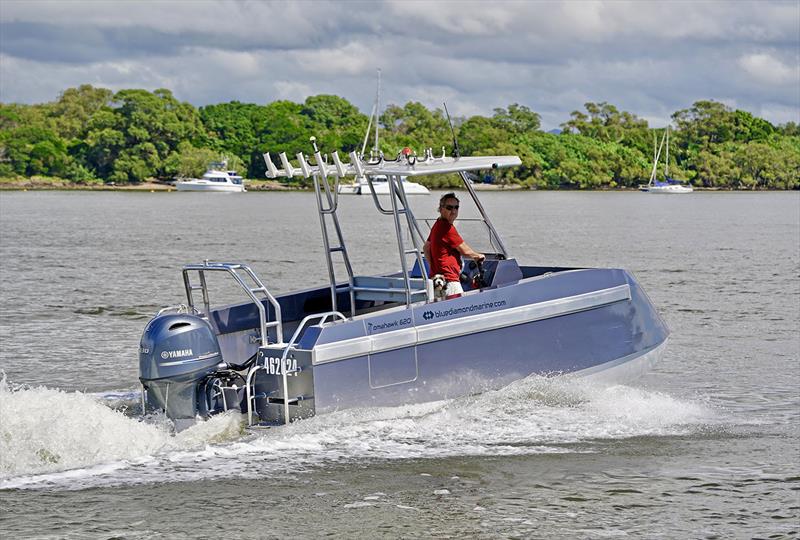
[{"x1": 183, "y1": 261, "x2": 283, "y2": 346}]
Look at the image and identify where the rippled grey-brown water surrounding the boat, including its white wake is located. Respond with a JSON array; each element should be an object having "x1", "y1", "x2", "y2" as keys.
[{"x1": 0, "y1": 192, "x2": 800, "y2": 538}]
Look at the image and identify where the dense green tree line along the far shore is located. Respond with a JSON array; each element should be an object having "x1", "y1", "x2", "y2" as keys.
[{"x1": 0, "y1": 85, "x2": 800, "y2": 189}]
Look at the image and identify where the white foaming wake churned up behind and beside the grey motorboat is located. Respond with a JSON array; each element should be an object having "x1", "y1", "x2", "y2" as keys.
[{"x1": 0, "y1": 377, "x2": 720, "y2": 489}]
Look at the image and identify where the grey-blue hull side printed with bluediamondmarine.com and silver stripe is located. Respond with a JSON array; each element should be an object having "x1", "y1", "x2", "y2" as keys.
[{"x1": 309, "y1": 269, "x2": 669, "y2": 413}]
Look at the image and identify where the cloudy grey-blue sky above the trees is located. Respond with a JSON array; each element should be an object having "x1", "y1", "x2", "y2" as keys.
[{"x1": 0, "y1": 0, "x2": 800, "y2": 129}]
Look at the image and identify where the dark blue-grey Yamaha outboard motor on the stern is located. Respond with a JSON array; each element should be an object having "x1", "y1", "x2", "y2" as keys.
[{"x1": 139, "y1": 313, "x2": 244, "y2": 429}]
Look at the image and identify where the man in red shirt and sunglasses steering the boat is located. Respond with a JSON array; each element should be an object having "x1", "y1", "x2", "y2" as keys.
[{"x1": 422, "y1": 193, "x2": 486, "y2": 297}]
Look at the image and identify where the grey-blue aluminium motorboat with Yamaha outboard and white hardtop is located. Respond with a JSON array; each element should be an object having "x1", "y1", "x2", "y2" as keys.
[{"x1": 139, "y1": 137, "x2": 669, "y2": 430}]
